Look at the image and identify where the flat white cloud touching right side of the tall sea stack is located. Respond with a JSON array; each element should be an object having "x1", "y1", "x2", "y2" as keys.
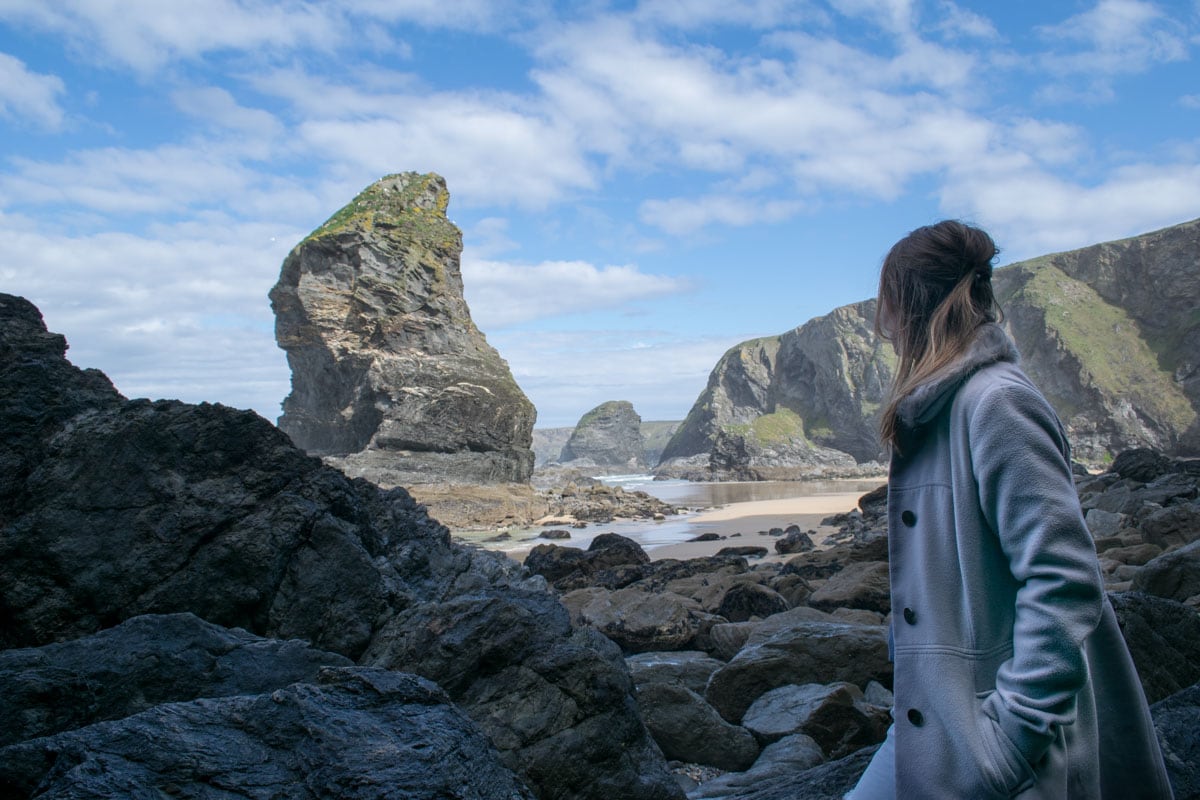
[{"x1": 462, "y1": 257, "x2": 690, "y2": 331}]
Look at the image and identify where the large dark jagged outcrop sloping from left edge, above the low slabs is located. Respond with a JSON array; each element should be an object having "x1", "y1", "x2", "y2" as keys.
[{"x1": 0, "y1": 295, "x2": 679, "y2": 800}]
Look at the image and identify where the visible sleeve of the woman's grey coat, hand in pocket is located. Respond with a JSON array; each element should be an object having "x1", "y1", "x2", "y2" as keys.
[{"x1": 968, "y1": 384, "x2": 1104, "y2": 766}]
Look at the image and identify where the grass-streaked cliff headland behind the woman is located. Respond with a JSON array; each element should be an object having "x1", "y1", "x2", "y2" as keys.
[{"x1": 656, "y1": 219, "x2": 1200, "y2": 480}]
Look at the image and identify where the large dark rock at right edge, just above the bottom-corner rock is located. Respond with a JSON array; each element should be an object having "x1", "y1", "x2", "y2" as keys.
[{"x1": 1109, "y1": 591, "x2": 1200, "y2": 703}]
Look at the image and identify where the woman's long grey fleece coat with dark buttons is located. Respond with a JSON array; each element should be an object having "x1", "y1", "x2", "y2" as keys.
[{"x1": 888, "y1": 325, "x2": 1171, "y2": 800}]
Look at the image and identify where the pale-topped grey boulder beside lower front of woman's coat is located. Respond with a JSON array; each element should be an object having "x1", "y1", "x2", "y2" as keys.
[{"x1": 742, "y1": 682, "x2": 890, "y2": 758}]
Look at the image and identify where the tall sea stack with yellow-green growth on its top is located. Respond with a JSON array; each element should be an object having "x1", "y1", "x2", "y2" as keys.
[{"x1": 270, "y1": 173, "x2": 535, "y2": 486}]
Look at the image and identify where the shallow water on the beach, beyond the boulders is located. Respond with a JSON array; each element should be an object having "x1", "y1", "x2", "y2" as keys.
[{"x1": 455, "y1": 475, "x2": 882, "y2": 558}]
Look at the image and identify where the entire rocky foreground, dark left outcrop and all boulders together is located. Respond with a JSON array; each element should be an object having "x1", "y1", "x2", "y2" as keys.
[{"x1": 0, "y1": 295, "x2": 1200, "y2": 800}]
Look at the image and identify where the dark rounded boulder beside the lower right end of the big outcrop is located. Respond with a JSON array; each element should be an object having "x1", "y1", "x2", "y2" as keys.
[{"x1": 637, "y1": 684, "x2": 758, "y2": 770}]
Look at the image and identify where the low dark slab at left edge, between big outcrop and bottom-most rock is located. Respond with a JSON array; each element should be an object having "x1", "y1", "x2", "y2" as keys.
[{"x1": 0, "y1": 614, "x2": 353, "y2": 745}]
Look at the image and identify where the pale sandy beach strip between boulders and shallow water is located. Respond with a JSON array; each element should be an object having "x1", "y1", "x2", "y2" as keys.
[{"x1": 461, "y1": 491, "x2": 863, "y2": 563}]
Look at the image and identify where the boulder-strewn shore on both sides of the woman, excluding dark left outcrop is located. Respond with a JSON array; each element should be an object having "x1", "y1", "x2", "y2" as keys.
[{"x1": 526, "y1": 450, "x2": 1200, "y2": 800}]
